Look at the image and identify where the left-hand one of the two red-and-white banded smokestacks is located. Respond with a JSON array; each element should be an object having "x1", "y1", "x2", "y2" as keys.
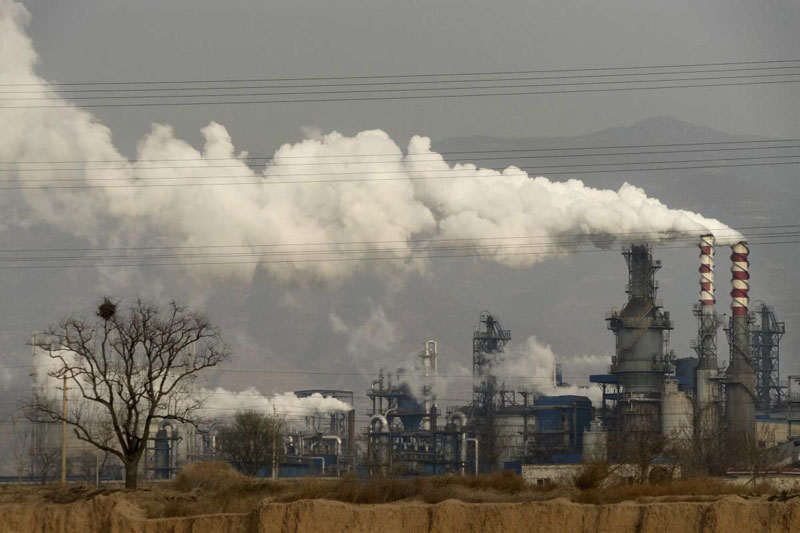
[{"x1": 694, "y1": 234, "x2": 721, "y2": 439}]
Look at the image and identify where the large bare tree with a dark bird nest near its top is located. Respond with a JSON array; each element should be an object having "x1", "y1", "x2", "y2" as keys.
[{"x1": 29, "y1": 298, "x2": 229, "y2": 488}]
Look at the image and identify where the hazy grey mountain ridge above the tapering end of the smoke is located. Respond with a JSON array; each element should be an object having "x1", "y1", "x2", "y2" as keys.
[{"x1": 433, "y1": 116, "x2": 800, "y2": 225}]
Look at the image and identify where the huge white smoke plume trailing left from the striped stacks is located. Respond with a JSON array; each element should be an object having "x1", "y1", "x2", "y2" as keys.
[{"x1": 0, "y1": 0, "x2": 738, "y2": 285}]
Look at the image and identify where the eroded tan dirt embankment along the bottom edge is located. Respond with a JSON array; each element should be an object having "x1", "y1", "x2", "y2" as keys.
[{"x1": 0, "y1": 492, "x2": 800, "y2": 533}]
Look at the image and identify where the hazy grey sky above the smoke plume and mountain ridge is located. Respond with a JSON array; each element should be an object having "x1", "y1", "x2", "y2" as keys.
[{"x1": 18, "y1": 0, "x2": 800, "y2": 153}]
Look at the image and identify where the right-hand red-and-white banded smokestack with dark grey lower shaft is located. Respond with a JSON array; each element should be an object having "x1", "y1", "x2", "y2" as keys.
[{"x1": 725, "y1": 241, "x2": 756, "y2": 449}]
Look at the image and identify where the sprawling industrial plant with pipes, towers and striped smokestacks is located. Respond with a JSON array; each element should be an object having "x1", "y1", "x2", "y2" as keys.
[{"x1": 26, "y1": 235, "x2": 800, "y2": 479}]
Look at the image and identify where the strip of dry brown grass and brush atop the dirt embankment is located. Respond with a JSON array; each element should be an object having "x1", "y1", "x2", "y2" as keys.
[{"x1": 0, "y1": 462, "x2": 780, "y2": 518}]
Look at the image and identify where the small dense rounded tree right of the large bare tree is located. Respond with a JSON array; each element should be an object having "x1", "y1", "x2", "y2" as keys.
[{"x1": 218, "y1": 411, "x2": 283, "y2": 476}]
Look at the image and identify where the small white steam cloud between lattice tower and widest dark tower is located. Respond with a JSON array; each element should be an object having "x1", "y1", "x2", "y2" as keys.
[{"x1": 504, "y1": 336, "x2": 610, "y2": 405}]
